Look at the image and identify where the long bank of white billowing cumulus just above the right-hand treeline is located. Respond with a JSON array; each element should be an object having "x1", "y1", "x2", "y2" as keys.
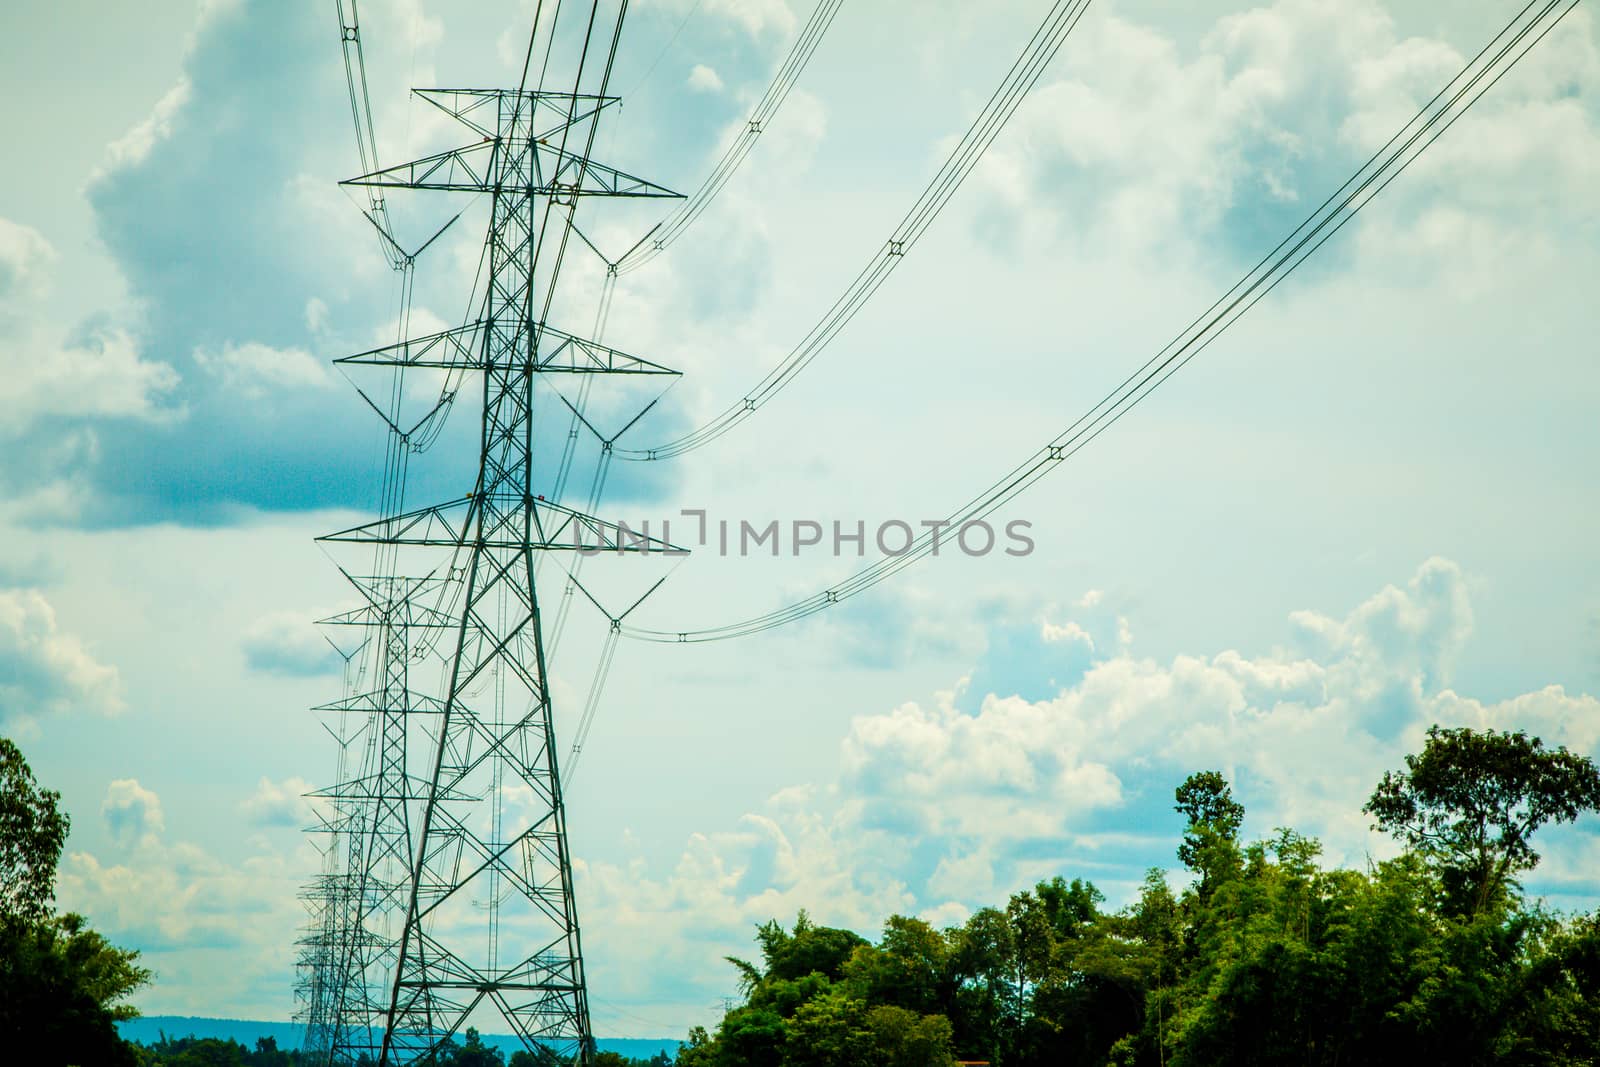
[{"x1": 582, "y1": 558, "x2": 1600, "y2": 1023}]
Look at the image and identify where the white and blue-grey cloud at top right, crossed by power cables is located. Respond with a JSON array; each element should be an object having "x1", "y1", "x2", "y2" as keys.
[{"x1": 979, "y1": 0, "x2": 1600, "y2": 267}]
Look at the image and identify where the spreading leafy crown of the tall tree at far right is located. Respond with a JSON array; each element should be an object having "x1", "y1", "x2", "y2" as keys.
[{"x1": 1362, "y1": 725, "x2": 1600, "y2": 915}]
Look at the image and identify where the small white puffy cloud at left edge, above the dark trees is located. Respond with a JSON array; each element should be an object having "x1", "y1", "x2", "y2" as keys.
[{"x1": 0, "y1": 589, "x2": 123, "y2": 731}]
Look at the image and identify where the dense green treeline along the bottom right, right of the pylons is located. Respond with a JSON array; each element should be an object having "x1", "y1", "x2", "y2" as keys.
[{"x1": 677, "y1": 728, "x2": 1600, "y2": 1067}]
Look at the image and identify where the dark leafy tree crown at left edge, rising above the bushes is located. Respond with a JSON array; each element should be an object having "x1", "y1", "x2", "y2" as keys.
[{"x1": 0, "y1": 737, "x2": 70, "y2": 921}]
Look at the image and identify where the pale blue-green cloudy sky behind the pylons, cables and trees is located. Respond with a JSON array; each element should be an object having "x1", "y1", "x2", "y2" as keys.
[{"x1": 0, "y1": 0, "x2": 1600, "y2": 1037}]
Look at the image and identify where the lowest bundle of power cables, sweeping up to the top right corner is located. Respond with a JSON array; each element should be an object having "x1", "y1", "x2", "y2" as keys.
[{"x1": 622, "y1": 0, "x2": 1579, "y2": 643}]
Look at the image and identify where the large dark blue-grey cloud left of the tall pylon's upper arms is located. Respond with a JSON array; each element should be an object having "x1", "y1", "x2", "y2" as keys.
[{"x1": 0, "y1": 3, "x2": 684, "y2": 526}]
